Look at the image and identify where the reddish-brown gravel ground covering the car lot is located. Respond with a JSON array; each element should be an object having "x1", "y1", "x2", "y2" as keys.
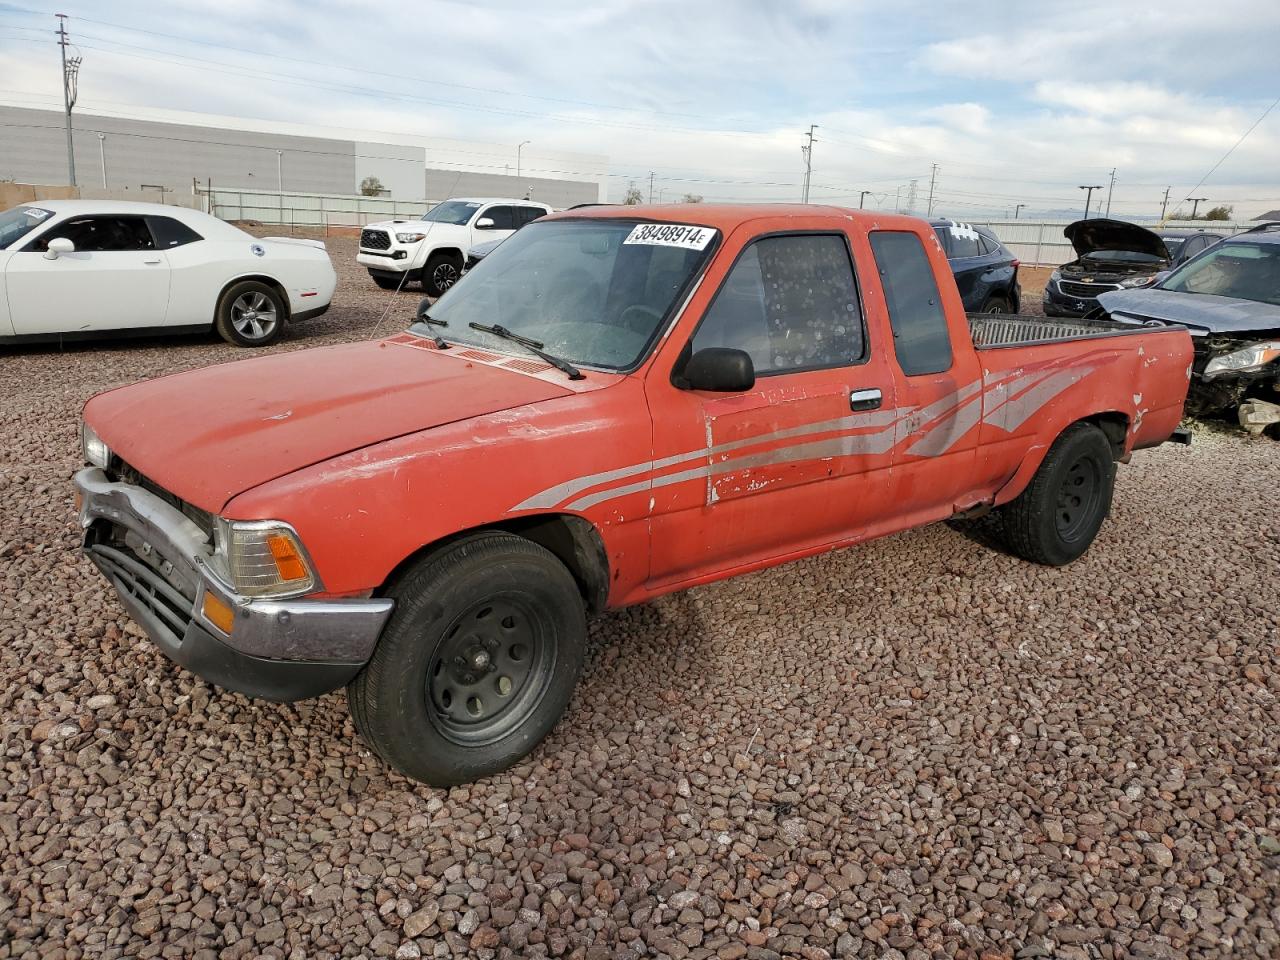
[{"x1": 0, "y1": 241, "x2": 1280, "y2": 960}]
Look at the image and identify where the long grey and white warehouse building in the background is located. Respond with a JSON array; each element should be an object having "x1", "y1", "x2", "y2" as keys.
[{"x1": 0, "y1": 102, "x2": 608, "y2": 207}]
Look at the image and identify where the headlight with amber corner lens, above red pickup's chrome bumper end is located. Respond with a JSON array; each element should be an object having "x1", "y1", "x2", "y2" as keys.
[{"x1": 215, "y1": 518, "x2": 319, "y2": 596}]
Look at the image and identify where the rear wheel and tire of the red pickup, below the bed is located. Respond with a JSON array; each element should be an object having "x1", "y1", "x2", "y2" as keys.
[{"x1": 1000, "y1": 424, "x2": 1116, "y2": 567}]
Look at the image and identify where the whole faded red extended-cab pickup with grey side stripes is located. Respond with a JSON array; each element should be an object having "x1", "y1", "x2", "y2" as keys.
[{"x1": 76, "y1": 205, "x2": 1192, "y2": 785}]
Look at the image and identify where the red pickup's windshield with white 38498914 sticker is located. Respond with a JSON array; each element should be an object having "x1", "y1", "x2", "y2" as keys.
[{"x1": 419, "y1": 219, "x2": 718, "y2": 370}]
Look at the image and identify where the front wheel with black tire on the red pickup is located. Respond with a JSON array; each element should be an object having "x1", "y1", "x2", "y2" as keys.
[{"x1": 347, "y1": 532, "x2": 586, "y2": 787}]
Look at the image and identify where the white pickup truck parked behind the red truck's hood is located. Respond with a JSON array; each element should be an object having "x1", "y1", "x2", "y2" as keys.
[{"x1": 356, "y1": 197, "x2": 552, "y2": 297}]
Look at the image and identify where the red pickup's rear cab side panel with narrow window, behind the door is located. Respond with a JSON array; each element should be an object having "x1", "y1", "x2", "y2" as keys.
[{"x1": 868, "y1": 230, "x2": 983, "y2": 527}]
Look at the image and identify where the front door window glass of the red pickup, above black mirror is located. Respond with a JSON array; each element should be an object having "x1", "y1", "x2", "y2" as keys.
[{"x1": 691, "y1": 234, "x2": 865, "y2": 376}]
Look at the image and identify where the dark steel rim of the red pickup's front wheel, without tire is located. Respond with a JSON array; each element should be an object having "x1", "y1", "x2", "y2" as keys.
[{"x1": 426, "y1": 596, "x2": 556, "y2": 746}]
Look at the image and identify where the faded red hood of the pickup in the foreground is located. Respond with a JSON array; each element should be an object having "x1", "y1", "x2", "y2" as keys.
[{"x1": 84, "y1": 340, "x2": 571, "y2": 513}]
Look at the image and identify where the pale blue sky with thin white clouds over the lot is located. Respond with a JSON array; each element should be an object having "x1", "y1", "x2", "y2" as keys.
[{"x1": 0, "y1": 0, "x2": 1280, "y2": 218}]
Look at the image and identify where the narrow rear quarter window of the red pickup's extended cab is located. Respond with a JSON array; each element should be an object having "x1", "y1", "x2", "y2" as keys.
[{"x1": 870, "y1": 230, "x2": 954, "y2": 376}]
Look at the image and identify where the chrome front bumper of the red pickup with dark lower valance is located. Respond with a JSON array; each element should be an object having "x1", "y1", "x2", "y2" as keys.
[{"x1": 74, "y1": 467, "x2": 393, "y2": 700}]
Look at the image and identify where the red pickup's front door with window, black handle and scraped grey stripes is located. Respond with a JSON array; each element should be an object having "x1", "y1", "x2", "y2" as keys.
[{"x1": 646, "y1": 229, "x2": 895, "y2": 586}]
